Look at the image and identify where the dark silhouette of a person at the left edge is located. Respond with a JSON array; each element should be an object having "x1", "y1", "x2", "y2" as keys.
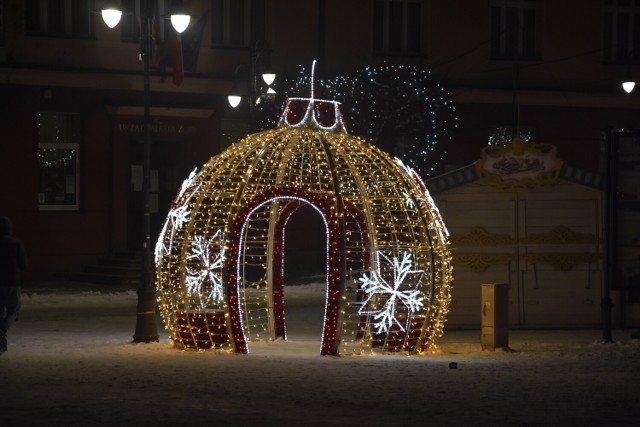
[{"x1": 0, "y1": 216, "x2": 27, "y2": 354}]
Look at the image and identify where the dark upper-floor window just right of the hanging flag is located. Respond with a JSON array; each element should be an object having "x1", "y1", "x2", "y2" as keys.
[{"x1": 211, "y1": 0, "x2": 265, "y2": 47}]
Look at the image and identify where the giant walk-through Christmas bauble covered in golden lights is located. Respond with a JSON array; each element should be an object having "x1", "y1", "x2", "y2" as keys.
[{"x1": 155, "y1": 65, "x2": 452, "y2": 355}]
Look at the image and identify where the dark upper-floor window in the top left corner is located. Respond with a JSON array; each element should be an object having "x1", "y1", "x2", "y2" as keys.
[{"x1": 26, "y1": 0, "x2": 93, "y2": 37}]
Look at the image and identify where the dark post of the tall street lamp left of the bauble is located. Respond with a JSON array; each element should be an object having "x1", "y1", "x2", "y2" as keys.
[{"x1": 133, "y1": 0, "x2": 159, "y2": 342}]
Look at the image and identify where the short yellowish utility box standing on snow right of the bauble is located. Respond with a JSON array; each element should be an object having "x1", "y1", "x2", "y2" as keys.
[{"x1": 480, "y1": 283, "x2": 509, "y2": 350}]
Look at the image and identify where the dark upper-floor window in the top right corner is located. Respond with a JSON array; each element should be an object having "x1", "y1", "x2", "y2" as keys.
[{"x1": 603, "y1": 0, "x2": 640, "y2": 64}]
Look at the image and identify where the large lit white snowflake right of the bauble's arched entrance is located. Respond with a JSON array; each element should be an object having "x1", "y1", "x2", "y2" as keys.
[{"x1": 358, "y1": 251, "x2": 424, "y2": 333}]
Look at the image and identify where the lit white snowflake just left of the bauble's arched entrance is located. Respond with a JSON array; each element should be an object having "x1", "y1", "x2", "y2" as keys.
[{"x1": 185, "y1": 230, "x2": 224, "y2": 309}]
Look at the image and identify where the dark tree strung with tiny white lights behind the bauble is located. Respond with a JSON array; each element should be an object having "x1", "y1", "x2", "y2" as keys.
[{"x1": 258, "y1": 64, "x2": 457, "y2": 177}]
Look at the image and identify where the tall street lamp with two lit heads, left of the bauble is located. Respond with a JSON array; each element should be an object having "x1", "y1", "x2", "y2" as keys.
[{"x1": 102, "y1": 0, "x2": 190, "y2": 342}]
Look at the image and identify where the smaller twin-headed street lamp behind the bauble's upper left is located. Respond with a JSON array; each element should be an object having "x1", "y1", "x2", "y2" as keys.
[{"x1": 227, "y1": 42, "x2": 276, "y2": 128}]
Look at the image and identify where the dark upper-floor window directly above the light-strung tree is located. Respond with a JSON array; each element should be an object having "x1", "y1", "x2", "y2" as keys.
[{"x1": 373, "y1": 0, "x2": 422, "y2": 54}]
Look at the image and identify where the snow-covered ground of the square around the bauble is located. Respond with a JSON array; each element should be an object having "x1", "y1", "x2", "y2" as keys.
[{"x1": 0, "y1": 284, "x2": 640, "y2": 427}]
